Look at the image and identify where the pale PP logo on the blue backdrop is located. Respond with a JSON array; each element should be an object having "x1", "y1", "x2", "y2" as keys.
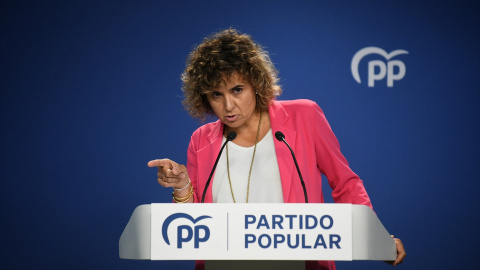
[{"x1": 351, "y1": 47, "x2": 408, "y2": 87}]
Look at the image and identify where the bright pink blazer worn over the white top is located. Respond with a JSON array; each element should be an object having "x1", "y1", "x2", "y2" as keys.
[{"x1": 187, "y1": 100, "x2": 372, "y2": 208}]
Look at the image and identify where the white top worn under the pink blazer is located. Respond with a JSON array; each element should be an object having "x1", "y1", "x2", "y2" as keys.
[{"x1": 212, "y1": 129, "x2": 283, "y2": 203}]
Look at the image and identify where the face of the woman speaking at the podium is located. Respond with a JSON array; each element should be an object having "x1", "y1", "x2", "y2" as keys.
[{"x1": 207, "y1": 73, "x2": 257, "y2": 131}]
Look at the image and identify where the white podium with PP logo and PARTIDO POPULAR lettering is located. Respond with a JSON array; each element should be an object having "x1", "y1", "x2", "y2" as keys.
[{"x1": 119, "y1": 203, "x2": 397, "y2": 269}]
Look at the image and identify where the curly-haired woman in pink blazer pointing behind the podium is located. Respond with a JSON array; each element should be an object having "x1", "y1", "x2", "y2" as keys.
[{"x1": 148, "y1": 29, "x2": 405, "y2": 269}]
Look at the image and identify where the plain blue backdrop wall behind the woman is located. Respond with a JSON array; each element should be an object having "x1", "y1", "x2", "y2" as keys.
[{"x1": 0, "y1": 0, "x2": 480, "y2": 269}]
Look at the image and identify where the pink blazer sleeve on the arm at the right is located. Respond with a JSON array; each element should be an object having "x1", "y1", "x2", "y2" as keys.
[{"x1": 313, "y1": 103, "x2": 372, "y2": 208}]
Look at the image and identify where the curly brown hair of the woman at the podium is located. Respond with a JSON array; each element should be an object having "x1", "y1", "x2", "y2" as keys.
[{"x1": 182, "y1": 28, "x2": 282, "y2": 121}]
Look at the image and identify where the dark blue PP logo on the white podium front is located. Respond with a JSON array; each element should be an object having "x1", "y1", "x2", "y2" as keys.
[{"x1": 162, "y1": 213, "x2": 212, "y2": 248}]
